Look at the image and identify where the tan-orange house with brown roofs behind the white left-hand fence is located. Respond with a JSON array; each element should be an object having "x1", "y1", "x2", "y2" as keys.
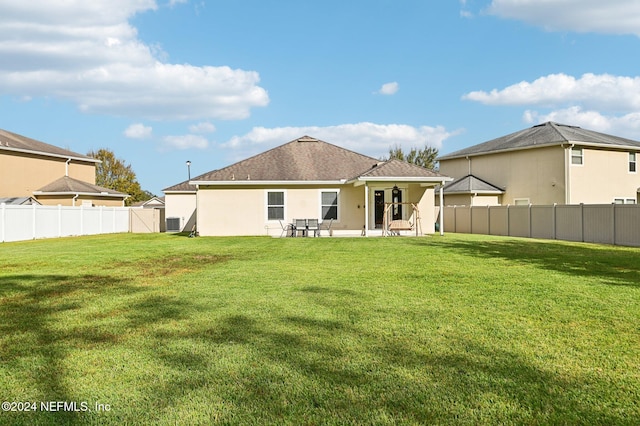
[{"x1": 0, "y1": 130, "x2": 128, "y2": 206}]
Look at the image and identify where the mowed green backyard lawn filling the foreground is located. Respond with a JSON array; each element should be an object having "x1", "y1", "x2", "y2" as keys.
[{"x1": 0, "y1": 234, "x2": 640, "y2": 425}]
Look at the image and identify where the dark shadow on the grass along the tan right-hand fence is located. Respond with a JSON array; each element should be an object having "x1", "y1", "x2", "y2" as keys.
[{"x1": 418, "y1": 239, "x2": 640, "y2": 288}]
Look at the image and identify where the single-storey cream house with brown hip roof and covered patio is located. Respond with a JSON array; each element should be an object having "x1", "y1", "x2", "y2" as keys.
[{"x1": 164, "y1": 136, "x2": 451, "y2": 235}]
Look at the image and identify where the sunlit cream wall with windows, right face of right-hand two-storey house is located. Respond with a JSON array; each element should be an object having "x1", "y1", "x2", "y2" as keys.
[{"x1": 569, "y1": 145, "x2": 640, "y2": 204}]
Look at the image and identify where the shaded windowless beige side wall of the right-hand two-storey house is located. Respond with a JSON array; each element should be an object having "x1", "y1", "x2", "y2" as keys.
[{"x1": 440, "y1": 146, "x2": 565, "y2": 205}]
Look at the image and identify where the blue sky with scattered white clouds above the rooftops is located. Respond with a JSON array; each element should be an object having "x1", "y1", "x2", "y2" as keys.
[{"x1": 0, "y1": 0, "x2": 640, "y2": 195}]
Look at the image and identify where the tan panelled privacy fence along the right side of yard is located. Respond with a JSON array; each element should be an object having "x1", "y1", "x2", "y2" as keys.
[{"x1": 444, "y1": 204, "x2": 640, "y2": 246}]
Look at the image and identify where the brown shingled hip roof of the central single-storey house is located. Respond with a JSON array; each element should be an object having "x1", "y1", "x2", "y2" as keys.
[{"x1": 186, "y1": 136, "x2": 450, "y2": 185}]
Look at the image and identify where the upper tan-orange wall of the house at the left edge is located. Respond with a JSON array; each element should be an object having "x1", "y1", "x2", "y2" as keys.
[{"x1": 0, "y1": 150, "x2": 96, "y2": 197}]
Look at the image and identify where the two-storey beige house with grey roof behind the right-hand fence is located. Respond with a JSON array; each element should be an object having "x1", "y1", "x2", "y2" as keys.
[{"x1": 438, "y1": 122, "x2": 640, "y2": 205}]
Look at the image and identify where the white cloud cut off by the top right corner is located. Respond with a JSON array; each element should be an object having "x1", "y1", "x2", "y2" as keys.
[{"x1": 488, "y1": 0, "x2": 640, "y2": 35}]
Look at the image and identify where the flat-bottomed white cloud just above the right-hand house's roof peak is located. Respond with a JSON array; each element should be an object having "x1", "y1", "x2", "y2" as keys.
[{"x1": 463, "y1": 74, "x2": 640, "y2": 111}]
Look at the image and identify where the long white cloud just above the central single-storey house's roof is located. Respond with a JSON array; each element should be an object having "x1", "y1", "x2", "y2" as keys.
[{"x1": 222, "y1": 122, "x2": 460, "y2": 159}]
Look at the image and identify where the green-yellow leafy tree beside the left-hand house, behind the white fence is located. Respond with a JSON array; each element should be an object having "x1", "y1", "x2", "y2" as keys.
[{"x1": 87, "y1": 148, "x2": 153, "y2": 206}]
